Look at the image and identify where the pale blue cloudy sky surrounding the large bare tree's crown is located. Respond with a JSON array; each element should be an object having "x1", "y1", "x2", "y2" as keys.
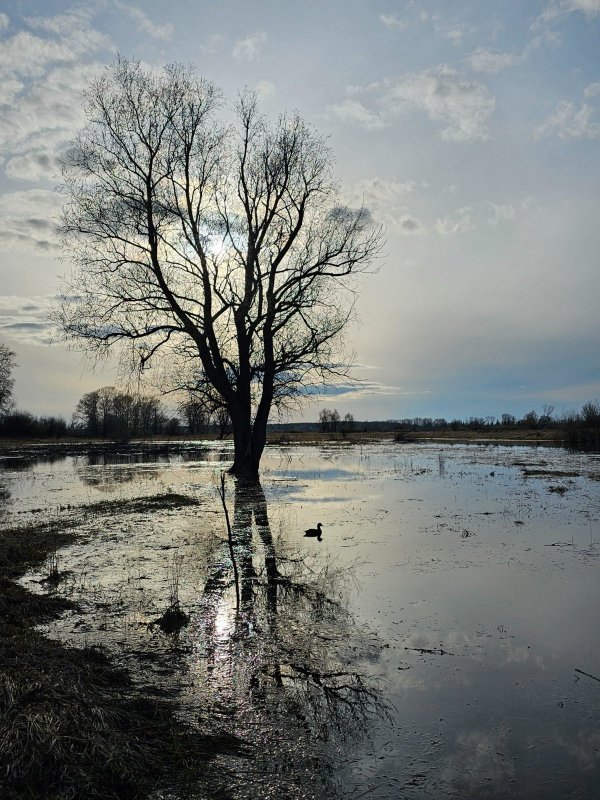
[{"x1": 0, "y1": 0, "x2": 600, "y2": 420}]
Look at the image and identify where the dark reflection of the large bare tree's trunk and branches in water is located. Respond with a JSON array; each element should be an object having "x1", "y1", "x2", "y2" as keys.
[{"x1": 197, "y1": 480, "x2": 387, "y2": 759}]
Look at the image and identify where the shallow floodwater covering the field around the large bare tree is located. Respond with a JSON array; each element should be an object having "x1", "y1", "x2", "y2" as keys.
[{"x1": 0, "y1": 442, "x2": 600, "y2": 800}]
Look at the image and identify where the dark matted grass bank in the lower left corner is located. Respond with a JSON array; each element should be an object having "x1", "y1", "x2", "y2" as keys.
[{"x1": 0, "y1": 512, "x2": 241, "y2": 800}]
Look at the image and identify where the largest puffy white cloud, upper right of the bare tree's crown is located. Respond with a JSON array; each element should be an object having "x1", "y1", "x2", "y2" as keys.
[{"x1": 381, "y1": 65, "x2": 495, "y2": 142}]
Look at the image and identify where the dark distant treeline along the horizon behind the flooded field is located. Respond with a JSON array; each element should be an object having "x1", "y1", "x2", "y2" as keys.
[{"x1": 0, "y1": 386, "x2": 600, "y2": 450}]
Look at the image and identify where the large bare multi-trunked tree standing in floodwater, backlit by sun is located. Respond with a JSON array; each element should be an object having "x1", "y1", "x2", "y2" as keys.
[{"x1": 59, "y1": 59, "x2": 382, "y2": 475}]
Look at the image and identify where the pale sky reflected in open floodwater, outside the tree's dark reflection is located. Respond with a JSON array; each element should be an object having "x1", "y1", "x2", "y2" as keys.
[{"x1": 0, "y1": 443, "x2": 600, "y2": 800}]
